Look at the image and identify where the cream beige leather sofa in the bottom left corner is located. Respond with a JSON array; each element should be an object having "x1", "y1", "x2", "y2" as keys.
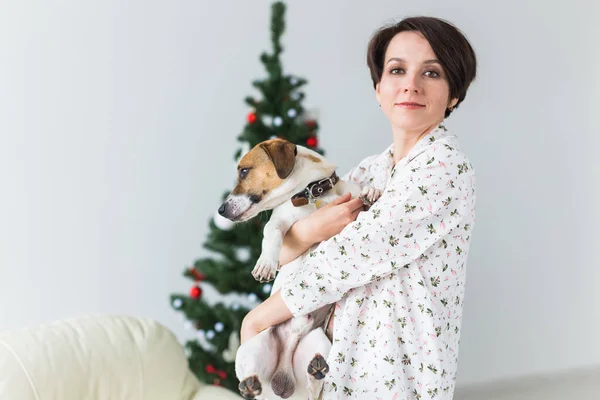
[{"x1": 0, "y1": 315, "x2": 241, "y2": 400}]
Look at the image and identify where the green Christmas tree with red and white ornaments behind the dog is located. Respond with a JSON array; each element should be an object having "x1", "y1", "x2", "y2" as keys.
[{"x1": 171, "y1": 2, "x2": 324, "y2": 392}]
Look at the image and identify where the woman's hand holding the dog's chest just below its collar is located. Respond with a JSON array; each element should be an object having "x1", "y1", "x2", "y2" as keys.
[{"x1": 298, "y1": 193, "x2": 364, "y2": 243}]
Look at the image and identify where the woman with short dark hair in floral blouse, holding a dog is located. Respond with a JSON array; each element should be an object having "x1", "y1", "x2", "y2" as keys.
[{"x1": 242, "y1": 17, "x2": 476, "y2": 399}]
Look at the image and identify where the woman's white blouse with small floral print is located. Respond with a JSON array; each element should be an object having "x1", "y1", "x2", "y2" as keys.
[{"x1": 281, "y1": 125, "x2": 475, "y2": 400}]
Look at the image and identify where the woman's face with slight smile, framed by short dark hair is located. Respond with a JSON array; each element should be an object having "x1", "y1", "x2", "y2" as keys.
[{"x1": 375, "y1": 32, "x2": 457, "y2": 132}]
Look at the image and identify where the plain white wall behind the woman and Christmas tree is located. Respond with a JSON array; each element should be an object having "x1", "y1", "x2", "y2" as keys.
[{"x1": 0, "y1": 0, "x2": 600, "y2": 385}]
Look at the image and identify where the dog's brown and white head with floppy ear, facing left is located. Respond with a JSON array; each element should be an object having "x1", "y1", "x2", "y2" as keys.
[{"x1": 219, "y1": 139, "x2": 298, "y2": 222}]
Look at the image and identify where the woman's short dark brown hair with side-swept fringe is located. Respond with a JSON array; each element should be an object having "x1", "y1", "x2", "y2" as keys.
[{"x1": 367, "y1": 16, "x2": 477, "y2": 117}]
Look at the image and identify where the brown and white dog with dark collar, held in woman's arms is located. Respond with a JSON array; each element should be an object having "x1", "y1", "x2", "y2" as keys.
[{"x1": 218, "y1": 139, "x2": 380, "y2": 399}]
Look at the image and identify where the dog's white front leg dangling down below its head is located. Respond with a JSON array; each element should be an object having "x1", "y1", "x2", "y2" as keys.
[{"x1": 252, "y1": 216, "x2": 291, "y2": 282}]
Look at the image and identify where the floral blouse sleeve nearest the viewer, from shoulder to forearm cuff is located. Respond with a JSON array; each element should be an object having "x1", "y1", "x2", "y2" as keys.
[{"x1": 281, "y1": 145, "x2": 474, "y2": 316}]
